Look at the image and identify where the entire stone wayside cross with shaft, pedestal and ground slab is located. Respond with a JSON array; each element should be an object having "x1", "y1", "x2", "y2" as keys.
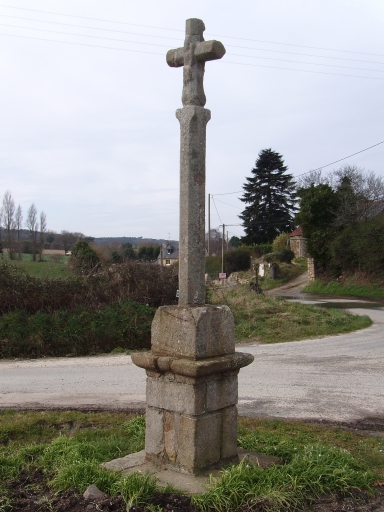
[{"x1": 106, "y1": 19, "x2": 253, "y2": 484}]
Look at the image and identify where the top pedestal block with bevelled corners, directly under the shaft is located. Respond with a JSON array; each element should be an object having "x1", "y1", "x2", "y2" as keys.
[{"x1": 151, "y1": 305, "x2": 235, "y2": 359}]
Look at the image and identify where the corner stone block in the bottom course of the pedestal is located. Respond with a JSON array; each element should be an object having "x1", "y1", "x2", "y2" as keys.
[{"x1": 177, "y1": 412, "x2": 222, "y2": 474}]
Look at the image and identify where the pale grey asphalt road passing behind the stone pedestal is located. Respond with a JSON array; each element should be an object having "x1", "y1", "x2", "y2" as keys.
[{"x1": 0, "y1": 299, "x2": 384, "y2": 425}]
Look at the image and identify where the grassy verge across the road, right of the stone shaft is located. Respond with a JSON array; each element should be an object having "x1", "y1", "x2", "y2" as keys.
[{"x1": 210, "y1": 285, "x2": 372, "y2": 343}]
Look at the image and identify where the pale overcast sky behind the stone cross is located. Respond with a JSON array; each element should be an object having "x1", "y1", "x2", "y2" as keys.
[{"x1": 0, "y1": 0, "x2": 384, "y2": 239}]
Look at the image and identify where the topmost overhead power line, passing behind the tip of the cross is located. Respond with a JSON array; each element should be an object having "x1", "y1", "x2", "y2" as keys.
[{"x1": 0, "y1": 4, "x2": 384, "y2": 57}]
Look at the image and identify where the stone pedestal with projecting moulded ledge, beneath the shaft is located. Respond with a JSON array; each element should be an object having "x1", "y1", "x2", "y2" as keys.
[{"x1": 132, "y1": 305, "x2": 253, "y2": 475}]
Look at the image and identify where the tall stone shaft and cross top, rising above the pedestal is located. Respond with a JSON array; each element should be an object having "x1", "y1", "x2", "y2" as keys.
[{"x1": 167, "y1": 18, "x2": 225, "y2": 305}]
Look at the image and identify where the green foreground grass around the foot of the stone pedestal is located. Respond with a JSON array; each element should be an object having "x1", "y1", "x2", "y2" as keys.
[{"x1": 0, "y1": 410, "x2": 384, "y2": 512}]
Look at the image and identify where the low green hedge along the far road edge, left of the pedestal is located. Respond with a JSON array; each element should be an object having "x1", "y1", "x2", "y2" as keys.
[{"x1": 0, "y1": 301, "x2": 155, "y2": 358}]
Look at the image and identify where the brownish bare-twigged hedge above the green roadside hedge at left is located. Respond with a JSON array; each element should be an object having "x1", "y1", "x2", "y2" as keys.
[{"x1": 0, "y1": 261, "x2": 177, "y2": 314}]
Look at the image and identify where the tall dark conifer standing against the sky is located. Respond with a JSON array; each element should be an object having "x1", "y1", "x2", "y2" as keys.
[{"x1": 239, "y1": 149, "x2": 295, "y2": 244}]
